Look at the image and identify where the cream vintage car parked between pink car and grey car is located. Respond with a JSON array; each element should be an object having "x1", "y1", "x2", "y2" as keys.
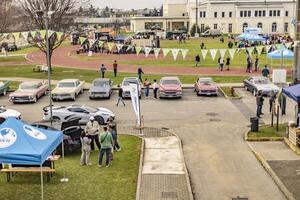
[{"x1": 52, "y1": 79, "x2": 85, "y2": 101}]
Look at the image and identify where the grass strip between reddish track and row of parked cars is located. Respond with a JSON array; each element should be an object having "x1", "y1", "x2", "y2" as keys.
[{"x1": 0, "y1": 65, "x2": 246, "y2": 84}]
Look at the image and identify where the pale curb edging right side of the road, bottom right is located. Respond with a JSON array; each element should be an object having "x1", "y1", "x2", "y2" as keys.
[{"x1": 246, "y1": 137, "x2": 296, "y2": 200}]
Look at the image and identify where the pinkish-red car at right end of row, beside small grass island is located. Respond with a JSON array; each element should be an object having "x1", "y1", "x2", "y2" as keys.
[{"x1": 195, "y1": 77, "x2": 218, "y2": 95}]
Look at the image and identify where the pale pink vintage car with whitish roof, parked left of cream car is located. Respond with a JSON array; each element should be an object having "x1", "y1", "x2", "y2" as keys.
[{"x1": 9, "y1": 81, "x2": 48, "y2": 103}]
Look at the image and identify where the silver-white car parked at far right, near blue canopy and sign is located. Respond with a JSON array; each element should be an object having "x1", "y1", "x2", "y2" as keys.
[{"x1": 244, "y1": 76, "x2": 279, "y2": 96}]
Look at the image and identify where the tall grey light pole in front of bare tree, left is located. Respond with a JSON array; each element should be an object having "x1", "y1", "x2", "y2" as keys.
[{"x1": 36, "y1": 10, "x2": 54, "y2": 126}]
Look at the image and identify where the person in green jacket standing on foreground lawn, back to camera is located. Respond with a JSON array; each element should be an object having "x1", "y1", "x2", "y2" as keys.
[{"x1": 98, "y1": 126, "x2": 113, "y2": 167}]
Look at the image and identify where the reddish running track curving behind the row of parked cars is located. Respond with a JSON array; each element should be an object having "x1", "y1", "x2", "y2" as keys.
[{"x1": 27, "y1": 46, "x2": 291, "y2": 76}]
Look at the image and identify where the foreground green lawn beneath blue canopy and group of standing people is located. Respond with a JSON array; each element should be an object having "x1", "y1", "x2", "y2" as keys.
[{"x1": 0, "y1": 135, "x2": 141, "y2": 200}]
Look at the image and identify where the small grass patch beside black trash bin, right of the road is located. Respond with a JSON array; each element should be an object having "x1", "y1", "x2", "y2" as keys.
[{"x1": 248, "y1": 124, "x2": 286, "y2": 139}]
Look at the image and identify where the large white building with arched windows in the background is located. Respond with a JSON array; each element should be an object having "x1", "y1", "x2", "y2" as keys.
[{"x1": 131, "y1": 0, "x2": 296, "y2": 35}]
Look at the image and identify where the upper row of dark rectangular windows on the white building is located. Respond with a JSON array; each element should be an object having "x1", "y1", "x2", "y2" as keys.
[{"x1": 199, "y1": 10, "x2": 289, "y2": 18}]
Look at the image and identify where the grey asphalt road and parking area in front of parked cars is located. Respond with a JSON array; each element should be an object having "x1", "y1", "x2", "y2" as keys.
[{"x1": 0, "y1": 90, "x2": 284, "y2": 200}]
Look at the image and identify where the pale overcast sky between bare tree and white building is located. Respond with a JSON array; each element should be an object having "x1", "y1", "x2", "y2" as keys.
[{"x1": 93, "y1": 0, "x2": 163, "y2": 9}]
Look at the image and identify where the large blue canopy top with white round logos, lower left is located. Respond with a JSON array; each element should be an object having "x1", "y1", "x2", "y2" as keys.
[{"x1": 0, "y1": 118, "x2": 63, "y2": 165}]
